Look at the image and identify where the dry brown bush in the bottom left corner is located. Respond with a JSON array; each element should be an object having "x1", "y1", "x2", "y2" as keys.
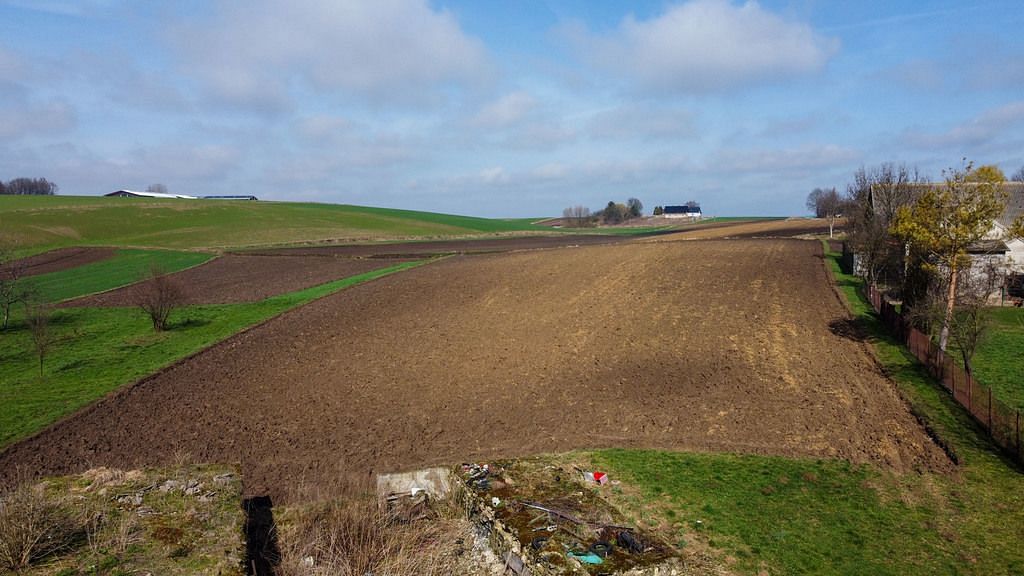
[{"x1": 0, "y1": 483, "x2": 85, "y2": 572}]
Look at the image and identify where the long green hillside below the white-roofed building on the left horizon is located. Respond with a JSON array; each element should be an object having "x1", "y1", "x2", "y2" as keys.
[{"x1": 0, "y1": 196, "x2": 552, "y2": 251}]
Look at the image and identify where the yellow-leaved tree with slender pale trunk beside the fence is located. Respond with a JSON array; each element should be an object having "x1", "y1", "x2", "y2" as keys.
[{"x1": 890, "y1": 162, "x2": 1007, "y2": 353}]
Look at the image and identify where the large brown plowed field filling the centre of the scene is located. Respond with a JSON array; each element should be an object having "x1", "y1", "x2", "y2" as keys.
[{"x1": 0, "y1": 235, "x2": 949, "y2": 499}]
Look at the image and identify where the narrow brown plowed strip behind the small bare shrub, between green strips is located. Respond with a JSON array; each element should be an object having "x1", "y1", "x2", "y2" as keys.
[{"x1": 63, "y1": 254, "x2": 404, "y2": 306}]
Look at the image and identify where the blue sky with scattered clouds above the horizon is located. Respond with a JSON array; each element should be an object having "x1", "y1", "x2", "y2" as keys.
[{"x1": 0, "y1": 0, "x2": 1024, "y2": 216}]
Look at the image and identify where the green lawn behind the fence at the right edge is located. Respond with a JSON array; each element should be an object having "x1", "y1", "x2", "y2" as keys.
[{"x1": 974, "y1": 307, "x2": 1024, "y2": 411}]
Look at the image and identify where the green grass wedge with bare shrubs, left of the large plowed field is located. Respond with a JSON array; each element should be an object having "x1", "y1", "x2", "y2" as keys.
[{"x1": 0, "y1": 261, "x2": 422, "y2": 447}]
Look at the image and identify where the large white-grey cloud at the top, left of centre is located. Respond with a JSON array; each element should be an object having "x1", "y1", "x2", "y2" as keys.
[{"x1": 172, "y1": 0, "x2": 488, "y2": 106}]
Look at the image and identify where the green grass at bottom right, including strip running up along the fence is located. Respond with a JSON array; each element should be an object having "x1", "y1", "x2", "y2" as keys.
[{"x1": 594, "y1": 239, "x2": 1024, "y2": 574}]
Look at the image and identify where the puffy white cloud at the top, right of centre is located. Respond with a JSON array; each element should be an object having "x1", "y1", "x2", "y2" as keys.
[{"x1": 569, "y1": 0, "x2": 839, "y2": 93}]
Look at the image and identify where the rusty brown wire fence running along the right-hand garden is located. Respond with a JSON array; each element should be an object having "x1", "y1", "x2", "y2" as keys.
[{"x1": 867, "y1": 286, "x2": 1024, "y2": 463}]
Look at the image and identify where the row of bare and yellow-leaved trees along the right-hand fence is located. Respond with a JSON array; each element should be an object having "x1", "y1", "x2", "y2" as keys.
[{"x1": 839, "y1": 162, "x2": 1024, "y2": 372}]
